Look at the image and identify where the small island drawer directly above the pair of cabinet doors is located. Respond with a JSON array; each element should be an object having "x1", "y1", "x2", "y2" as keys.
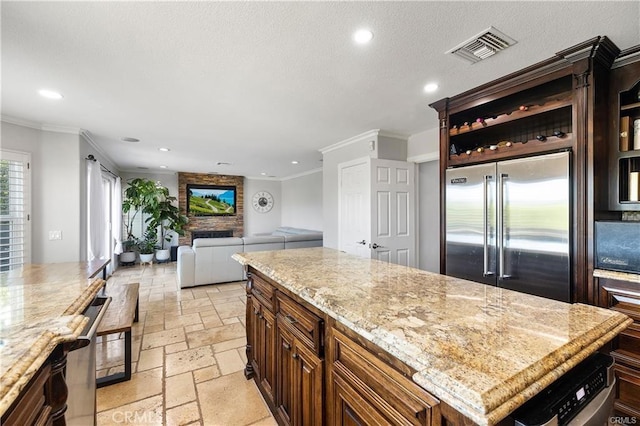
[{"x1": 276, "y1": 292, "x2": 323, "y2": 356}]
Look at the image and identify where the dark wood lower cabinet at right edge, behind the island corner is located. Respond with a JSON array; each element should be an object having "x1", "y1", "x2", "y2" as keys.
[{"x1": 596, "y1": 278, "x2": 640, "y2": 416}]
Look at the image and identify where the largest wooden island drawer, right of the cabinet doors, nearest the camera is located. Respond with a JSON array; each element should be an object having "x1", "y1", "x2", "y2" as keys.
[{"x1": 331, "y1": 328, "x2": 440, "y2": 425}]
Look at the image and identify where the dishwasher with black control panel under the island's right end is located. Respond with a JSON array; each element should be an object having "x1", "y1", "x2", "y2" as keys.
[{"x1": 512, "y1": 353, "x2": 616, "y2": 426}]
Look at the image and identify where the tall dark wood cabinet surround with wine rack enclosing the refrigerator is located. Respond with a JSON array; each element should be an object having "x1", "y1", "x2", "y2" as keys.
[{"x1": 430, "y1": 37, "x2": 620, "y2": 302}]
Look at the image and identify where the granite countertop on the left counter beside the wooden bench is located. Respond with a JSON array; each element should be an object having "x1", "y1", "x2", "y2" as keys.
[{"x1": 0, "y1": 262, "x2": 105, "y2": 416}]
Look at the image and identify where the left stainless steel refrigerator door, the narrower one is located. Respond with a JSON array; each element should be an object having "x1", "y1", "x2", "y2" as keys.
[{"x1": 445, "y1": 163, "x2": 497, "y2": 285}]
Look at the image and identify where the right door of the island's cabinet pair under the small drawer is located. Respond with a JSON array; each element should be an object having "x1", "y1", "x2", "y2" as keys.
[{"x1": 291, "y1": 339, "x2": 324, "y2": 426}]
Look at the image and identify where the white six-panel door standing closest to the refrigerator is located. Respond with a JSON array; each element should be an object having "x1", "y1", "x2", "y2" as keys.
[{"x1": 370, "y1": 159, "x2": 417, "y2": 267}]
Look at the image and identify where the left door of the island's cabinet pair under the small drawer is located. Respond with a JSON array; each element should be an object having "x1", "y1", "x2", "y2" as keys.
[{"x1": 275, "y1": 324, "x2": 294, "y2": 424}]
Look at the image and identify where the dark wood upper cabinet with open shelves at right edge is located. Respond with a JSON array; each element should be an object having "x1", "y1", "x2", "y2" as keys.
[{"x1": 609, "y1": 46, "x2": 640, "y2": 211}]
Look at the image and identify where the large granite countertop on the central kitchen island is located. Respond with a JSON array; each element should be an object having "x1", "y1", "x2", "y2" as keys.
[{"x1": 233, "y1": 248, "x2": 632, "y2": 425}]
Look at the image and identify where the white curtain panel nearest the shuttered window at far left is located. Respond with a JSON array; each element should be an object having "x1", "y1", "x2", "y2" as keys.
[{"x1": 87, "y1": 160, "x2": 106, "y2": 260}]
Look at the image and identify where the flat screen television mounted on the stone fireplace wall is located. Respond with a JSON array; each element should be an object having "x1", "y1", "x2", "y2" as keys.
[{"x1": 187, "y1": 184, "x2": 236, "y2": 216}]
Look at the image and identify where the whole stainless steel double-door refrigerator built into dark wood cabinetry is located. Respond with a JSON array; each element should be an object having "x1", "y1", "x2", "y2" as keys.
[{"x1": 445, "y1": 152, "x2": 571, "y2": 302}]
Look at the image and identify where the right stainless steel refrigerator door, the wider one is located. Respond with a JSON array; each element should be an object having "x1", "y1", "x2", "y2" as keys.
[{"x1": 497, "y1": 152, "x2": 571, "y2": 302}]
